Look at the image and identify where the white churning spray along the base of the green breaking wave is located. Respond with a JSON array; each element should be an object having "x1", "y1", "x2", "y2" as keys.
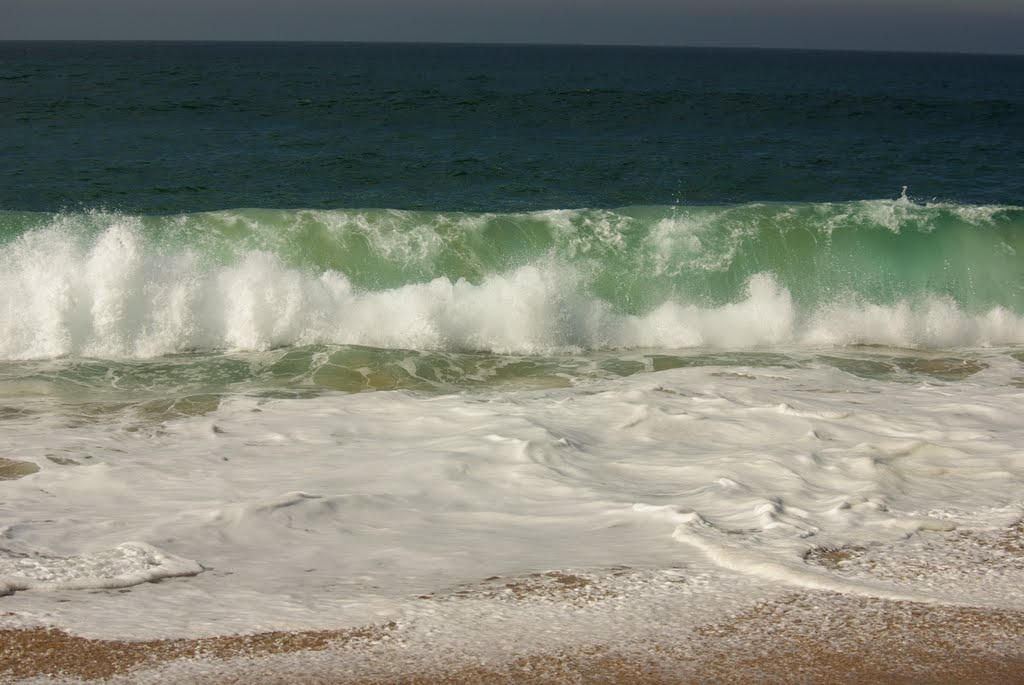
[{"x1": 0, "y1": 217, "x2": 1024, "y2": 359}]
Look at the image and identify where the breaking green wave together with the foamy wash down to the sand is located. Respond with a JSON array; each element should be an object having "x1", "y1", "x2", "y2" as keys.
[{"x1": 0, "y1": 198, "x2": 1024, "y2": 658}]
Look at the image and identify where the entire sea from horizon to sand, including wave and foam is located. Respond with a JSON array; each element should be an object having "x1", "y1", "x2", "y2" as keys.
[{"x1": 0, "y1": 42, "x2": 1024, "y2": 679}]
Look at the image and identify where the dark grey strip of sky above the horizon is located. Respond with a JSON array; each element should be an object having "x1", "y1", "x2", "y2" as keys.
[{"x1": 0, "y1": 0, "x2": 1024, "y2": 53}]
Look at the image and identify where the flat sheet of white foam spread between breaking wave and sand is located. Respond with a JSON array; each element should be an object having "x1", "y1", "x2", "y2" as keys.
[{"x1": 0, "y1": 357, "x2": 1024, "y2": 639}]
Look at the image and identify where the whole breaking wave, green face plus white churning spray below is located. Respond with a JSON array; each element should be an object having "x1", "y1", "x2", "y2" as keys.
[{"x1": 0, "y1": 200, "x2": 1024, "y2": 358}]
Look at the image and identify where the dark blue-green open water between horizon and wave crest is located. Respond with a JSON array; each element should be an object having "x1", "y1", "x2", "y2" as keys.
[{"x1": 6, "y1": 43, "x2": 1024, "y2": 213}]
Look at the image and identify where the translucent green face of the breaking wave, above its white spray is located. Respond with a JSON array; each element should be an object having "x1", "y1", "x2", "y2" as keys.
[{"x1": 0, "y1": 201, "x2": 1024, "y2": 313}]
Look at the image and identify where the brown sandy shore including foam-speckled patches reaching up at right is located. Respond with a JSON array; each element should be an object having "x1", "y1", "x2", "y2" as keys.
[{"x1": 8, "y1": 521, "x2": 1024, "y2": 685}]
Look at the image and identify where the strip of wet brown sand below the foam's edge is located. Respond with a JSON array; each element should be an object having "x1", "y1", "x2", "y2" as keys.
[{"x1": 0, "y1": 592, "x2": 1024, "y2": 685}]
